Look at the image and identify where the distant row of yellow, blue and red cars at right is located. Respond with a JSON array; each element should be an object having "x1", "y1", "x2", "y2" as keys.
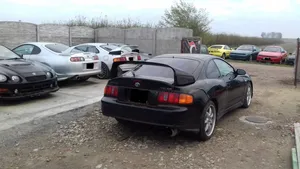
[{"x1": 208, "y1": 44, "x2": 296, "y2": 64}]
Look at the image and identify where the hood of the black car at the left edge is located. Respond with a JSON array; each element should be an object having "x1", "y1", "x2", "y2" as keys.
[{"x1": 0, "y1": 59, "x2": 52, "y2": 77}]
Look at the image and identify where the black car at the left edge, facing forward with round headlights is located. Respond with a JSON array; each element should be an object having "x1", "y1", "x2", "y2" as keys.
[{"x1": 0, "y1": 45, "x2": 59, "y2": 100}]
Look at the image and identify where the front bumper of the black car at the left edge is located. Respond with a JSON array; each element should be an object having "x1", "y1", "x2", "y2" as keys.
[{"x1": 0, "y1": 79, "x2": 59, "y2": 100}]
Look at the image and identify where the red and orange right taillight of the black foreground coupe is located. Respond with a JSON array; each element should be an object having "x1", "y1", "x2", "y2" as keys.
[{"x1": 157, "y1": 92, "x2": 194, "y2": 104}]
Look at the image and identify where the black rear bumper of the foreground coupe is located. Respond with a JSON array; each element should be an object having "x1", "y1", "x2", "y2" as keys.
[{"x1": 101, "y1": 97, "x2": 201, "y2": 131}]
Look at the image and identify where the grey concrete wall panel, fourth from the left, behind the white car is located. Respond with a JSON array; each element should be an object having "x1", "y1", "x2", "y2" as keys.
[{"x1": 95, "y1": 28, "x2": 125, "y2": 43}]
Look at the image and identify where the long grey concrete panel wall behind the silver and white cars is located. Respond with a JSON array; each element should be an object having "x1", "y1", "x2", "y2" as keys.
[{"x1": 0, "y1": 22, "x2": 193, "y2": 56}]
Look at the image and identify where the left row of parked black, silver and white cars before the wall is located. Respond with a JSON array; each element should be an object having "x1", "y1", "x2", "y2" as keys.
[{"x1": 0, "y1": 42, "x2": 149, "y2": 100}]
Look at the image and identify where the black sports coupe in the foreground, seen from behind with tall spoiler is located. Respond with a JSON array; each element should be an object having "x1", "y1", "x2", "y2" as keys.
[{"x1": 101, "y1": 54, "x2": 253, "y2": 141}]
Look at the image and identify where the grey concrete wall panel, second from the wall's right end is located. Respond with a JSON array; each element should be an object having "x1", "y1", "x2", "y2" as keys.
[{"x1": 125, "y1": 28, "x2": 156, "y2": 54}]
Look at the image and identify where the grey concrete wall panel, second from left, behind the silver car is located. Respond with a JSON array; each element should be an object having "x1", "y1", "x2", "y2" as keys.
[{"x1": 38, "y1": 24, "x2": 70, "y2": 45}]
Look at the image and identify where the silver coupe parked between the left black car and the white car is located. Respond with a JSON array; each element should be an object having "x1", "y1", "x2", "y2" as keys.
[{"x1": 13, "y1": 42, "x2": 101, "y2": 81}]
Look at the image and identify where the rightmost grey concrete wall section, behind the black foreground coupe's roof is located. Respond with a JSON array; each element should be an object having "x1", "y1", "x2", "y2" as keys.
[{"x1": 155, "y1": 28, "x2": 193, "y2": 55}]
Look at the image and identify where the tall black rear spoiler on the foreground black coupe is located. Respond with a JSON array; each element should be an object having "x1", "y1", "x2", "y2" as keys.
[{"x1": 110, "y1": 61, "x2": 195, "y2": 86}]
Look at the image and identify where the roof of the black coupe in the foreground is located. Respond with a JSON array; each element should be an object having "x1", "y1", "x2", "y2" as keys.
[{"x1": 153, "y1": 53, "x2": 220, "y2": 61}]
